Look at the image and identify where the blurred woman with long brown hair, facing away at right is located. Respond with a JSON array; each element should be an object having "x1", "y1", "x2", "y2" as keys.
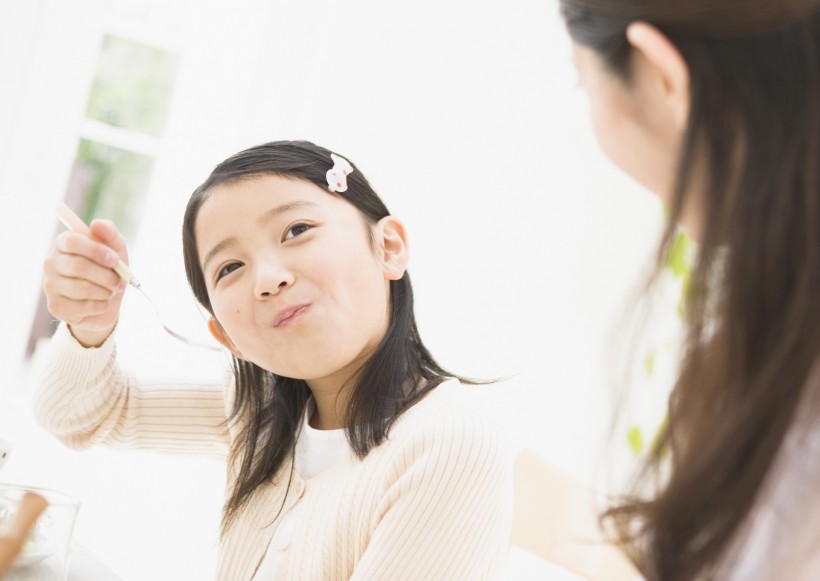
[{"x1": 561, "y1": 0, "x2": 820, "y2": 580}]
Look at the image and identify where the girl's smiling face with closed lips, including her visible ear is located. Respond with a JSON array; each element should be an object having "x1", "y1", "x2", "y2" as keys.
[{"x1": 195, "y1": 175, "x2": 406, "y2": 386}]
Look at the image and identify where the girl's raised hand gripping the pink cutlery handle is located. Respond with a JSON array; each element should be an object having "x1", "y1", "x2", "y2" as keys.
[{"x1": 43, "y1": 220, "x2": 128, "y2": 347}]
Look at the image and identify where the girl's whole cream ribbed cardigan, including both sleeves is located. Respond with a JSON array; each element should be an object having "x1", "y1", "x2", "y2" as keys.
[{"x1": 35, "y1": 324, "x2": 512, "y2": 581}]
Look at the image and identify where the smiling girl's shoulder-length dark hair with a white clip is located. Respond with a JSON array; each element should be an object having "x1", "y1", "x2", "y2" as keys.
[{"x1": 182, "y1": 141, "x2": 470, "y2": 533}]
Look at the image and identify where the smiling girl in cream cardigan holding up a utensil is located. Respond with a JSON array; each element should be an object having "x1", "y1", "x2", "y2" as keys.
[{"x1": 36, "y1": 142, "x2": 512, "y2": 581}]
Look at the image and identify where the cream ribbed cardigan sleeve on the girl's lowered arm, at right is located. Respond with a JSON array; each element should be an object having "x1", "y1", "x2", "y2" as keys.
[{"x1": 351, "y1": 410, "x2": 513, "y2": 581}]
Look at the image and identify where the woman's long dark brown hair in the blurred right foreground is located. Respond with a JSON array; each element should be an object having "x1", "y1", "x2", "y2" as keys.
[{"x1": 561, "y1": 0, "x2": 820, "y2": 581}]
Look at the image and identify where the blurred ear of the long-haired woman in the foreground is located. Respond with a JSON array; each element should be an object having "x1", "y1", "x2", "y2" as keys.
[{"x1": 626, "y1": 22, "x2": 689, "y2": 131}]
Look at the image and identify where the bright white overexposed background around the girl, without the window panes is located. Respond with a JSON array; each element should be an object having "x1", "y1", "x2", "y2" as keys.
[{"x1": 0, "y1": 0, "x2": 662, "y2": 581}]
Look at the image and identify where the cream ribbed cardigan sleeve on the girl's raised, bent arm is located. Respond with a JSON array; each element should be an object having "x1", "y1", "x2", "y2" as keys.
[{"x1": 34, "y1": 323, "x2": 229, "y2": 458}]
